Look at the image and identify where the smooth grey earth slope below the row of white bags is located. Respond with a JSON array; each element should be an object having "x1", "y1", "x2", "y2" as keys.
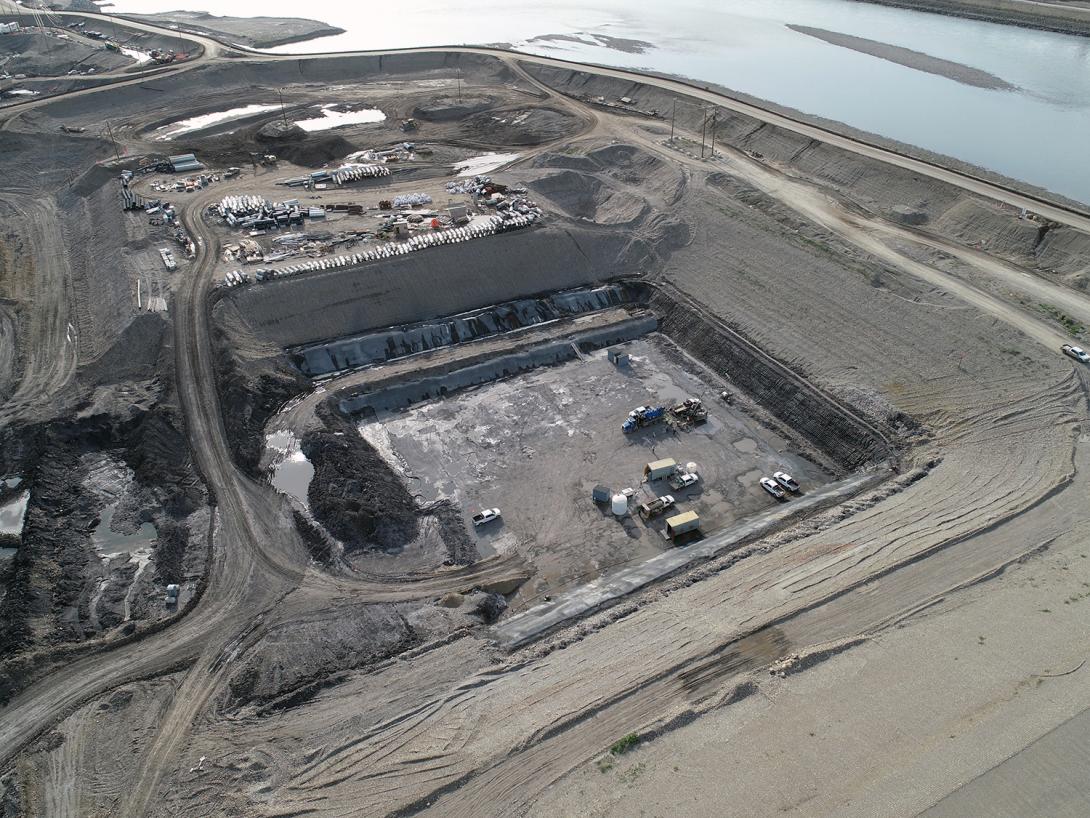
[{"x1": 216, "y1": 226, "x2": 632, "y2": 349}]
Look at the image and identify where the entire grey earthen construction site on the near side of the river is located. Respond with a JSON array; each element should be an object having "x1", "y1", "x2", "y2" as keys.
[{"x1": 0, "y1": 3, "x2": 1090, "y2": 817}]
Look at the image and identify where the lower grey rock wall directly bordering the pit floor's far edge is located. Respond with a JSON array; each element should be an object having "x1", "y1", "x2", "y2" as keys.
[{"x1": 339, "y1": 313, "x2": 658, "y2": 414}]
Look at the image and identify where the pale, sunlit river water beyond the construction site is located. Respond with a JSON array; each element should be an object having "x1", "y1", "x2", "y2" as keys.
[{"x1": 106, "y1": 0, "x2": 1090, "y2": 203}]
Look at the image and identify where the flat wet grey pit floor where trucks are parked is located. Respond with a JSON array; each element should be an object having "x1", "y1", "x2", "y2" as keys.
[{"x1": 361, "y1": 335, "x2": 829, "y2": 609}]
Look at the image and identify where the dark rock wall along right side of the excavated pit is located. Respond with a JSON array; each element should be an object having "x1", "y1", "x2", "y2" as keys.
[{"x1": 651, "y1": 291, "x2": 892, "y2": 471}]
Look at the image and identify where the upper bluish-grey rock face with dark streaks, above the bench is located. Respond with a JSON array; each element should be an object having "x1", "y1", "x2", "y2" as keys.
[{"x1": 289, "y1": 284, "x2": 642, "y2": 377}]
